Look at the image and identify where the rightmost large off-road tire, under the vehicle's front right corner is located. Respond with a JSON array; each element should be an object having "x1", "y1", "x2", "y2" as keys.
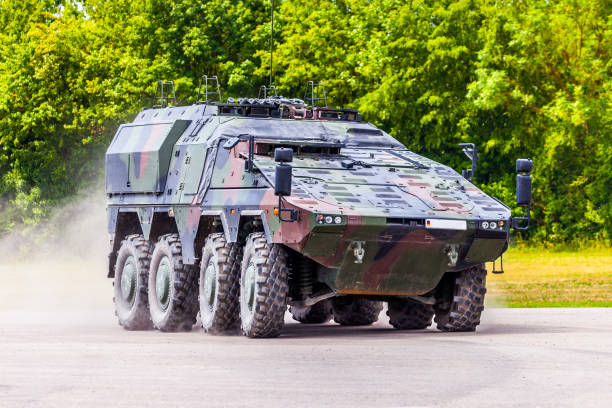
[{"x1": 434, "y1": 265, "x2": 487, "y2": 332}]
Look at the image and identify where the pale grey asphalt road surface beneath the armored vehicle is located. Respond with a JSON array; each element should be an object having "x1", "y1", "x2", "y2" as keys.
[{"x1": 0, "y1": 304, "x2": 612, "y2": 408}]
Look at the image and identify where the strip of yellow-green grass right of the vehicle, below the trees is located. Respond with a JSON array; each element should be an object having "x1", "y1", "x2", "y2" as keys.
[{"x1": 487, "y1": 248, "x2": 612, "y2": 307}]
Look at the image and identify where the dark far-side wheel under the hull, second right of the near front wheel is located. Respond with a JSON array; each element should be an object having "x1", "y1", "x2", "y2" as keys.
[{"x1": 331, "y1": 296, "x2": 383, "y2": 326}]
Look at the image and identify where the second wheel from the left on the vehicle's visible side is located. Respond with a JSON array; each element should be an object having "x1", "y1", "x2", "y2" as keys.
[{"x1": 149, "y1": 234, "x2": 198, "y2": 332}]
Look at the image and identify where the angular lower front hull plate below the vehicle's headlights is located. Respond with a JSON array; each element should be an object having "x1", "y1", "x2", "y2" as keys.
[{"x1": 302, "y1": 220, "x2": 508, "y2": 296}]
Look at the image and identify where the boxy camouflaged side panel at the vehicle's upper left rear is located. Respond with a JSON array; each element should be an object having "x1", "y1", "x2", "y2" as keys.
[{"x1": 106, "y1": 120, "x2": 190, "y2": 194}]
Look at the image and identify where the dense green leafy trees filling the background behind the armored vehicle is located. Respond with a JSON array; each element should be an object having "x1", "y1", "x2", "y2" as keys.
[{"x1": 0, "y1": 0, "x2": 612, "y2": 243}]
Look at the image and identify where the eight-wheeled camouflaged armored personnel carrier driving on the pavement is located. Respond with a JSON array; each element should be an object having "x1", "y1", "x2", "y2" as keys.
[{"x1": 106, "y1": 78, "x2": 532, "y2": 337}]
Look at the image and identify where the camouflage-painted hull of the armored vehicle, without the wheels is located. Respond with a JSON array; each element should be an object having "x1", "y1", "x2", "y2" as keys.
[{"x1": 106, "y1": 104, "x2": 511, "y2": 295}]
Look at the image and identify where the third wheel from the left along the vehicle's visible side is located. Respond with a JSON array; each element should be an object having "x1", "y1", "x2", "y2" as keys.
[{"x1": 200, "y1": 233, "x2": 242, "y2": 334}]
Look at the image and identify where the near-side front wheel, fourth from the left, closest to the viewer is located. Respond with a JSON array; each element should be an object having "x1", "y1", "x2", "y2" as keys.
[{"x1": 240, "y1": 233, "x2": 289, "y2": 337}]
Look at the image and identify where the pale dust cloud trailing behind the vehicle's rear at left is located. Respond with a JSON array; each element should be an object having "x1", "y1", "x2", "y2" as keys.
[{"x1": 0, "y1": 188, "x2": 112, "y2": 314}]
